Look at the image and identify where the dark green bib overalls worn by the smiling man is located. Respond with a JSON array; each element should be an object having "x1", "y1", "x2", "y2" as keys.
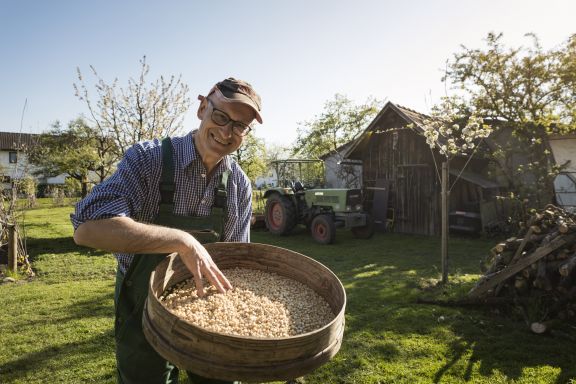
[{"x1": 114, "y1": 138, "x2": 236, "y2": 384}]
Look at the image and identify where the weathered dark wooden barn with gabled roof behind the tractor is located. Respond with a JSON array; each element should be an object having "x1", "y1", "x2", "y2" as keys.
[{"x1": 345, "y1": 102, "x2": 500, "y2": 235}]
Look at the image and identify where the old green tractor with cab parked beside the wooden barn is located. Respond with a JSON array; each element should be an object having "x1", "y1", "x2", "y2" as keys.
[{"x1": 264, "y1": 159, "x2": 374, "y2": 244}]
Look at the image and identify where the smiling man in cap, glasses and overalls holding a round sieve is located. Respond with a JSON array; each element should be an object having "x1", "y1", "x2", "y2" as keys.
[{"x1": 71, "y1": 78, "x2": 262, "y2": 384}]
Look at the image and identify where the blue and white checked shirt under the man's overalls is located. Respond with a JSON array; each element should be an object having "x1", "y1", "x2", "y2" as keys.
[{"x1": 70, "y1": 132, "x2": 252, "y2": 273}]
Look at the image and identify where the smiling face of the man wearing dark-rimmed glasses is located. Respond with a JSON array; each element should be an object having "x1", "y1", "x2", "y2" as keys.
[{"x1": 194, "y1": 92, "x2": 255, "y2": 159}]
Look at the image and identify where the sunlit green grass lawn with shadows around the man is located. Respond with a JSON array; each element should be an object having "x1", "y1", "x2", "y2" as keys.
[{"x1": 0, "y1": 204, "x2": 576, "y2": 384}]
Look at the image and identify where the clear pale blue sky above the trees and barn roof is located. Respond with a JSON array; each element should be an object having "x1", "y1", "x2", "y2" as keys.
[{"x1": 0, "y1": 0, "x2": 576, "y2": 145}]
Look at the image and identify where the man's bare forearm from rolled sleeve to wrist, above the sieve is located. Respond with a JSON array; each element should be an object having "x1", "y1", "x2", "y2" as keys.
[{"x1": 74, "y1": 217, "x2": 191, "y2": 253}]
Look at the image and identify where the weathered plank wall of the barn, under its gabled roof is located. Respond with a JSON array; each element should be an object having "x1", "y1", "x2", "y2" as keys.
[{"x1": 362, "y1": 108, "x2": 490, "y2": 235}]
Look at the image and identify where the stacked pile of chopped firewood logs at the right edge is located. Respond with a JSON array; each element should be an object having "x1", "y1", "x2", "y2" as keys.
[{"x1": 468, "y1": 205, "x2": 576, "y2": 333}]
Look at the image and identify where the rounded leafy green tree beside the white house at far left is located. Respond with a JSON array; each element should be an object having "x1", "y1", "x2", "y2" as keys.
[{"x1": 28, "y1": 118, "x2": 117, "y2": 197}]
